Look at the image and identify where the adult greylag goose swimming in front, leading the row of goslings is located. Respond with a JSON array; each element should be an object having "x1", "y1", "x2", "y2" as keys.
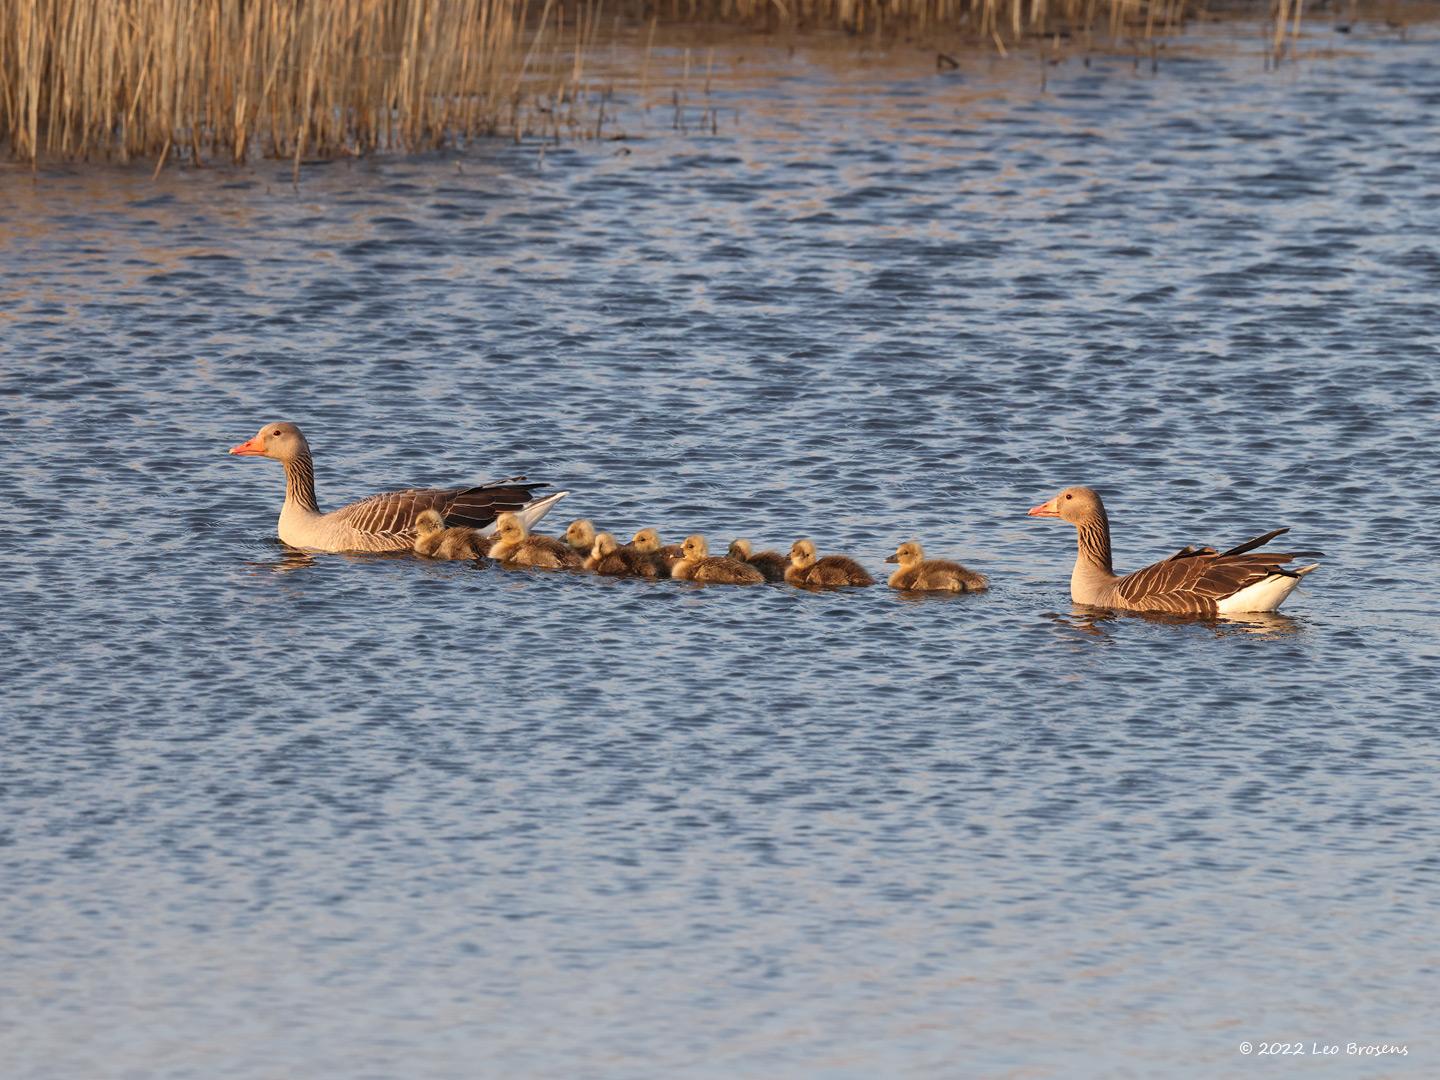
[{"x1": 230, "y1": 423, "x2": 569, "y2": 552}]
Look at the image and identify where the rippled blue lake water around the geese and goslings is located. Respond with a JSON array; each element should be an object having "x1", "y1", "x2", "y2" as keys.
[{"x1": 0, "y1": 24, "x2": 1440, "y2": 1080}]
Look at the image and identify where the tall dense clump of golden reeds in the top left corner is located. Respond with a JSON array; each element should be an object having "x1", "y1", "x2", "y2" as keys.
[{"x1": 0, "y1": 0, "x2": 595, "y2": 161}]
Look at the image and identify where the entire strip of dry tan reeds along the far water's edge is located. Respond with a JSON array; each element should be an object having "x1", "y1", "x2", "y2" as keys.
[{"x1": 0, "y1": 0, "x2": 1416, "y2": 170}]
